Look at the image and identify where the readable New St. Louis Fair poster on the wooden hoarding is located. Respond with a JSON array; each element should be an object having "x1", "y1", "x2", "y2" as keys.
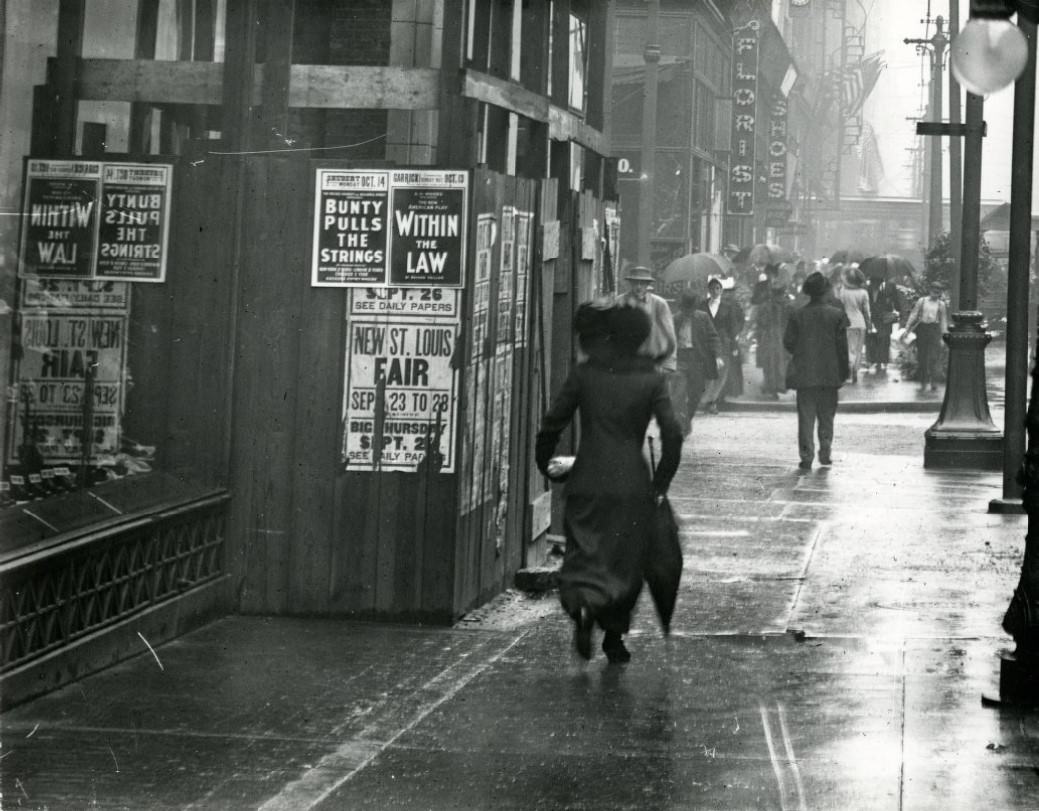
[{"x1": 342, "y1": 319, "x2": 459, "y2": 472}]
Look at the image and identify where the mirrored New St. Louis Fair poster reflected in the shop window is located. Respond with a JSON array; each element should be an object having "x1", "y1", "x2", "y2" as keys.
[{"x1": 9, "y1": 312, "x2": 127, "y2": 464}]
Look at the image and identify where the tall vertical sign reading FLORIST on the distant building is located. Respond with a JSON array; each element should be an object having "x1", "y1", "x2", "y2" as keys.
[{"x1": 726, "y1": 20, "x2": 761, "y2": 216}]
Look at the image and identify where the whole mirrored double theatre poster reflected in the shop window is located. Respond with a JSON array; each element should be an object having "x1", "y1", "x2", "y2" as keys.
[{"x1": 20, "y1": 159, "x2": 172, "y2": 281}]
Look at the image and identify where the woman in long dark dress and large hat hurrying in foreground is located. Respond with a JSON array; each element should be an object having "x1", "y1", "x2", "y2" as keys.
[{"x1": 535, "y1": 304, "x2": 682, "y2": 663}]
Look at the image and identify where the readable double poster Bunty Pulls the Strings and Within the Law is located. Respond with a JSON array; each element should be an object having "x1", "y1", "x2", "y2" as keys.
[{"x1": 311, "y1": 169, "x2": 469, "y2": 288}]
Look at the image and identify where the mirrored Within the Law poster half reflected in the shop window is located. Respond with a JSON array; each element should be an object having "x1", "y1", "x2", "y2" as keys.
[{"x1": 21, "y1": 160, "x2": 102, "y2": 278}]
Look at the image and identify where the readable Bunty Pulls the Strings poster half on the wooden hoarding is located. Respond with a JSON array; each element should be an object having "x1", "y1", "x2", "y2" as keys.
[{"x1": 311, "y1": 169, "x2": 390, "y2": 287}]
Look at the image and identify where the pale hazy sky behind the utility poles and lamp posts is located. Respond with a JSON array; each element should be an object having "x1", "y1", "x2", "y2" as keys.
[{"x1": 849, "y1": 0, "x2": 1014, "y2": 200}]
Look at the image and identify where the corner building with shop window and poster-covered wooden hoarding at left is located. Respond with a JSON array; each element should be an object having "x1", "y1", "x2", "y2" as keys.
[{"x1": 0, "y1": 0, "x2": 619, "y2": 703}]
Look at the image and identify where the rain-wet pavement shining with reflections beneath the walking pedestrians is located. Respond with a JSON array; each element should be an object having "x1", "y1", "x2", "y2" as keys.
[{"x1": 2, "y1": 404, "x2": 1039, "y2": 810}]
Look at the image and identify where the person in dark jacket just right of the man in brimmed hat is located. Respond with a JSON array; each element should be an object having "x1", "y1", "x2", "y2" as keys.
[{"x1": 671, "y1": 290, "x2": 722, "y2": 436}]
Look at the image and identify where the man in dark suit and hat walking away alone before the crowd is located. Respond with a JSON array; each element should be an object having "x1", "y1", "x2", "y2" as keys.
[{"x1": 782, "y1": 272, "x2": 851, "y2": 470}]
